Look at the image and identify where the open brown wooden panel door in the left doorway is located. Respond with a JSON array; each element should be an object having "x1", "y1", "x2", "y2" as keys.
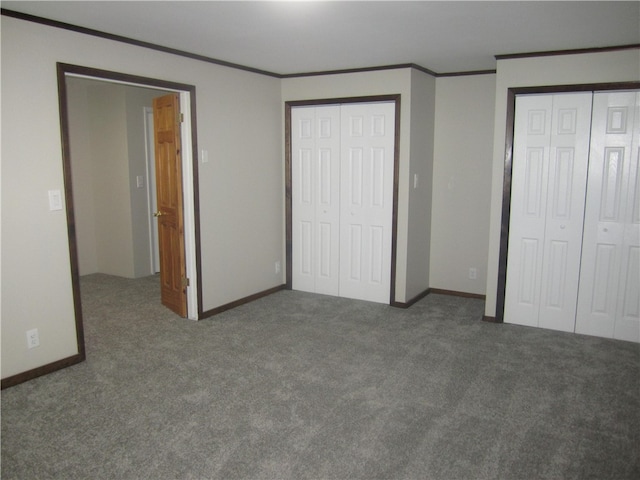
[{"x1": 153, "y1": 94, "x2": 187, "y2": 317}]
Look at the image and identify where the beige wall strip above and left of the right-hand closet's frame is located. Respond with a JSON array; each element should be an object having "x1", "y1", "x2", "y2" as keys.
[{"x1": 485, "y1": 49, "x2": 640, "y2": 317}]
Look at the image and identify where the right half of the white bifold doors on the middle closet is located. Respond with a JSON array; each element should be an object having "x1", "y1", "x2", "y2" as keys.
[{"x1": 340, "y1": 103, "x2": 395, "y2": 303}]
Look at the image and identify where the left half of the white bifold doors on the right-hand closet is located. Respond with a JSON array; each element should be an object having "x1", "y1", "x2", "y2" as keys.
[{"x1": 504, "y1": 93, "x2": 592, "y2": 332}]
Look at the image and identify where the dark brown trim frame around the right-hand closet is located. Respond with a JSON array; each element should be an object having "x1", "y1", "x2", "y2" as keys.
[{"x1": 496, "y1": 82, "x2": 640, "y2": 323}]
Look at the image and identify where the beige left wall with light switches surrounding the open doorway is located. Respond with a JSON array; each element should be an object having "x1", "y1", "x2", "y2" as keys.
[{"x1": 1, "y1": 16, "x2": 284, "y2": 378}]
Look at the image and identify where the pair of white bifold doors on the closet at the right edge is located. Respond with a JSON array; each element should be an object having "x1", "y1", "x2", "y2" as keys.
[{"x1": 504, "y1": 91, "x2": 640, "y2": 342}]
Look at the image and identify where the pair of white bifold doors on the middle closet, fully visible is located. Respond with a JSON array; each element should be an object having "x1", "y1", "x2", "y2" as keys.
[{"x1": 291, "y1": 102, "x2": 395, "y2": 303}]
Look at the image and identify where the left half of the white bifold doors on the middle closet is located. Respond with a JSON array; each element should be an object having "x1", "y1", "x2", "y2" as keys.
[{"x1": 291, "y1": 105, "x2": 340, "y2": 295}]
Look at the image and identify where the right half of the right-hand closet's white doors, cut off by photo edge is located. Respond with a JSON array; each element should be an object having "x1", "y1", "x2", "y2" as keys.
[{"x1": 576, "y1": 92, "x2": 640, "y2": 342}]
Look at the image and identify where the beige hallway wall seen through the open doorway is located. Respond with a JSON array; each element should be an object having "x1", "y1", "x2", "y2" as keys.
[{"x1": 67, "y1": 77, "x2": 166, "y2": 278}]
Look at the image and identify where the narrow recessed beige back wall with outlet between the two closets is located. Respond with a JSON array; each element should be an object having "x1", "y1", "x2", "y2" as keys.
[{"x1": 430, "y1": 74, "x2": 496, "y2": 295}]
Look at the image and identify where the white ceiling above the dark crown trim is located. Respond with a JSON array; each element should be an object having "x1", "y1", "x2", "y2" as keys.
[{"x1": 2, "y1": 1, "x2": 640, "y2": 74}]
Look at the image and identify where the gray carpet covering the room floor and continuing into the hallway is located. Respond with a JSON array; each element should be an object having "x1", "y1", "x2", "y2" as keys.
[{"x1": 2, "y1": 275, "x2": 640, "y2": 480}]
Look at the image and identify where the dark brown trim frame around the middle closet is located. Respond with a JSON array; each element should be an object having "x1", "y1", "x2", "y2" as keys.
[{"x1": 284, "y1": 94, "x2": 401, "y2": 306}]
